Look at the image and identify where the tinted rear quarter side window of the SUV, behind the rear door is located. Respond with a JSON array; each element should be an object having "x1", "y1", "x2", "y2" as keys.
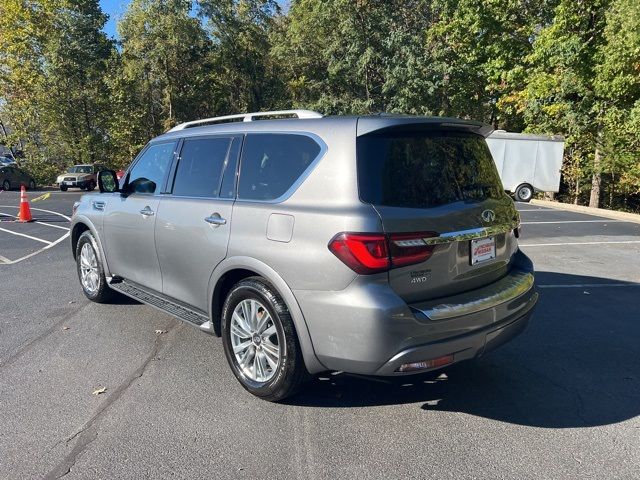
[{"x1": 238, "y1": 134, "x2": 320, "y2": 200}]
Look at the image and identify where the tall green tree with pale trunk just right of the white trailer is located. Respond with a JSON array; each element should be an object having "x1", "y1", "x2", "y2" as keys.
[{"x1": 520, "y1": 0, "x2": 609, "y2": 206}]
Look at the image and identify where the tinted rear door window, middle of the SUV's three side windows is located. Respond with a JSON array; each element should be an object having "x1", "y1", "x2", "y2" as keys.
[{"x1": 173, "y1": 138, "x2": 231, "y2": 197}]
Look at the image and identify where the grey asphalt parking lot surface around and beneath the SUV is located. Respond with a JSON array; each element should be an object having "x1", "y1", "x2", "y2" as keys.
[{"x1": 0, "y1": 192, "x2": 640, "y2": 479}]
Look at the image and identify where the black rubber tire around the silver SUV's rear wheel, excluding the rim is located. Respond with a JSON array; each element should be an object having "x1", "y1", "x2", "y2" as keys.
[{"x1": 221, "y1": 277, "x2": 309, "y2": 402}]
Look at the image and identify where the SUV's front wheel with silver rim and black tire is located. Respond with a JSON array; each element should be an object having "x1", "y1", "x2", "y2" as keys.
[{"x1": 76, "y1": 231, "x2": 114, "y2": 303}]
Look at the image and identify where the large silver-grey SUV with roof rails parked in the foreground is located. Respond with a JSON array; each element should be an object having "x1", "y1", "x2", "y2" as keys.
[{"x1": 71, "y1": 110, "x2": 537, "y2": 401}]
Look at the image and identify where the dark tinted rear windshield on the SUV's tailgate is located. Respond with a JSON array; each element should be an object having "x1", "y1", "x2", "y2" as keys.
[{"x1": 357, "y1": 131, "x2": 504, "y2": 208}]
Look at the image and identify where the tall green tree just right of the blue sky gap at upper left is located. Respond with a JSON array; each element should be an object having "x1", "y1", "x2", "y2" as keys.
[{"x1": 115, "y1": 0, "x2": 210, "y2": 148}]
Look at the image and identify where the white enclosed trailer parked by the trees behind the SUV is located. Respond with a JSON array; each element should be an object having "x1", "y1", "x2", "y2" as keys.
[{"x1": 487, "y1": 130, "x2": 564, "y2": 202}]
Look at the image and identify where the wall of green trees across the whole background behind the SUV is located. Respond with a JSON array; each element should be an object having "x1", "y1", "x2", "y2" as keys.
[{"x1": 0, "y1": 0, "x2": 640, "y2": 209}]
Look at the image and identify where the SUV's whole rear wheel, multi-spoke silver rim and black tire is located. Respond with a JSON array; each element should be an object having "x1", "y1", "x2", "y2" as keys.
[{"x1": 222, "y1": 277, "x2": 308, "y2": 402}]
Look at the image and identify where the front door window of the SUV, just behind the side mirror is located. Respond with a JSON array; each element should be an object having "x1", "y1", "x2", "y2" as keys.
[{"x1": 128, "y1": 142, "x2": 175, "y2": 193}]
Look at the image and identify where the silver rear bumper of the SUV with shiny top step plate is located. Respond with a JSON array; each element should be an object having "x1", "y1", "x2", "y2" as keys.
[{"x1": 294, "y1": 252, "x2": 538, "y2": 375}]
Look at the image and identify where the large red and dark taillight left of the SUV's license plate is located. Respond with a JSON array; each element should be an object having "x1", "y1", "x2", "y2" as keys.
[{"x1": 329, "y1": 232, "x2": 437, "y2": 275}]
